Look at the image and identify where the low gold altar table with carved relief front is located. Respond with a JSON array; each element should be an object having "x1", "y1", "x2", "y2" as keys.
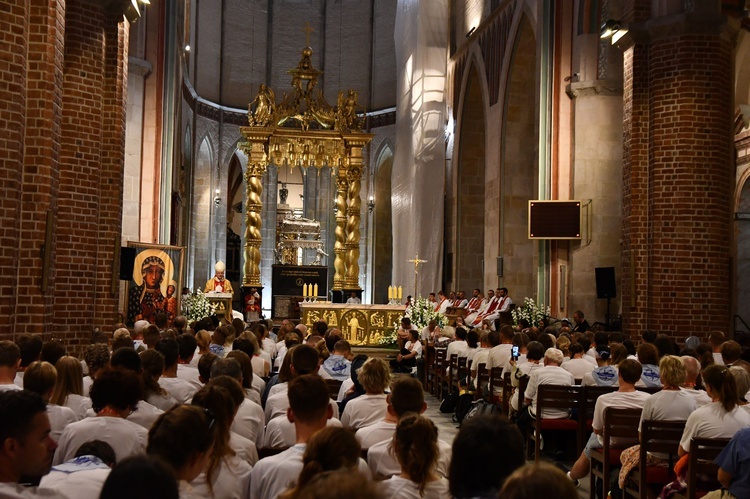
[{"x1": 300, "y1": 303, "x2": 404, "y2": 345}]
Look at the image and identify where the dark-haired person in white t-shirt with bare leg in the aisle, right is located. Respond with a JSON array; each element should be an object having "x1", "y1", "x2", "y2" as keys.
[{"x1": 568, "y1": 359, "x2": 650, "y2": 481}]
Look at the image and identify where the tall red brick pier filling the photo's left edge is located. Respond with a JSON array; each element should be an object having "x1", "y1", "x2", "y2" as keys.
[{"x1": 0, "y1": 0, "x2": 128, "y2": 352}]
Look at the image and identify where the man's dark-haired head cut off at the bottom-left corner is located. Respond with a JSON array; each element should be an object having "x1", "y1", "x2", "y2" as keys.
[{"x1": 0, "y1": 394, "x2": 59, "y2": 497}]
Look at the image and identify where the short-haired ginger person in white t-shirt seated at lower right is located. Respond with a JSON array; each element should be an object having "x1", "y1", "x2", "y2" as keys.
[{"x1": 619, "y1": 358, "x2": 698, "y2": 488}]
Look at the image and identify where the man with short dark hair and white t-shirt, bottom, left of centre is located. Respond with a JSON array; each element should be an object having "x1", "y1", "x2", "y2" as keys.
[{"x1": 249, "y1": 376, "x2": 352, "y2": 499}]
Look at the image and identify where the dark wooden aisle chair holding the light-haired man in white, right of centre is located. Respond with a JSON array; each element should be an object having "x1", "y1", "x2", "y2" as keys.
[{"x1": 518, "y1": 379, "x2": 582, "y2": 461}]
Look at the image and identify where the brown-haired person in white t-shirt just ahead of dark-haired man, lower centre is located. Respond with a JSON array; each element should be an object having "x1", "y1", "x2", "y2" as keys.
[{"x1": 341, "y1": 357, "x2": 391, "y2": 430}]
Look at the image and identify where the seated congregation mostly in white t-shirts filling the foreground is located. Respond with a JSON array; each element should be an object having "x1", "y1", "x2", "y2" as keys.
[{"x1": 0, "y1": 296, "x2": 750, "y2": 499}]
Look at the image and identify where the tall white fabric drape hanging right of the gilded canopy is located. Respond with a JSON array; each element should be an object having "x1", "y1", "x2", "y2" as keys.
[{"x1": 391, "y1": 0, "x2": 449, "y2": 297}]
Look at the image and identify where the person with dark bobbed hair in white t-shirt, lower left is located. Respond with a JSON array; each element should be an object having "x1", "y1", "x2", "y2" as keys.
[{"x1": 53, "y1": 367, "x2": 147, "y2": 464}]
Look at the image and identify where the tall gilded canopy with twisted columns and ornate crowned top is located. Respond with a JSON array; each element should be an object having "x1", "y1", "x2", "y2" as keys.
[{"x1": 240, "y1": 41, "x2": 373, "y2": 291}]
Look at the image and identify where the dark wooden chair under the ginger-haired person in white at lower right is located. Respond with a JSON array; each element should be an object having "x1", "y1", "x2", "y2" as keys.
[{"x1": 623, "y1": 419, "x2": 685, "y2": 499}]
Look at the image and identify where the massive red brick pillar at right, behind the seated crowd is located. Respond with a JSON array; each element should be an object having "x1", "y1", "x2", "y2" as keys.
[{"x1": 622, "y1": 1, "x2": 733, "y2": 338}]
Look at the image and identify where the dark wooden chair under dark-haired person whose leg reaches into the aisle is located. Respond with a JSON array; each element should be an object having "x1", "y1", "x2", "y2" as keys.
[{"x1": 590, "y1": 407, "x2": 642, "y2": 499}]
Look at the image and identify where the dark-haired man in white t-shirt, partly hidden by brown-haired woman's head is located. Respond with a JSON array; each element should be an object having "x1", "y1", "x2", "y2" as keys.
[{"x1": 364, "y1": 378, "x2": 452, "y2": 478}]
